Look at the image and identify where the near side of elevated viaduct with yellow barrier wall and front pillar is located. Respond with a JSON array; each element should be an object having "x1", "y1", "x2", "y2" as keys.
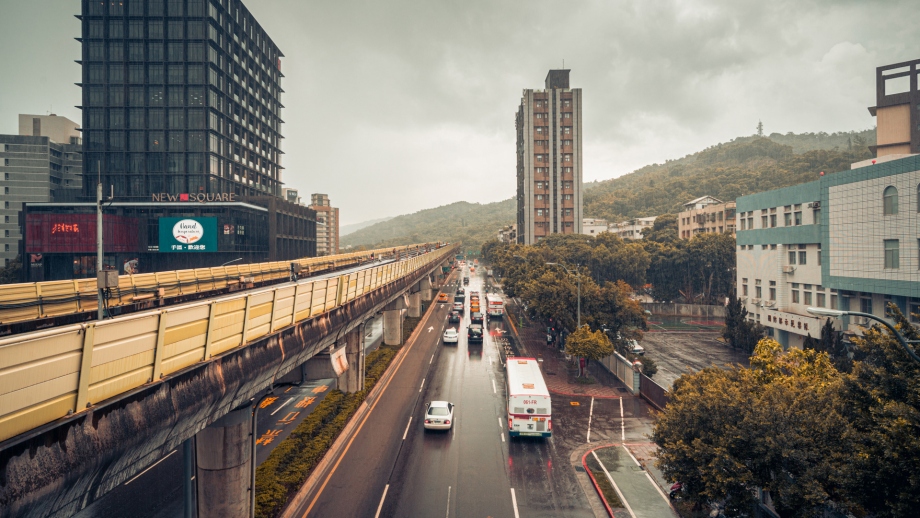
[{"x1": 0, "y1": 245, "x2": 456, "y2": 516}]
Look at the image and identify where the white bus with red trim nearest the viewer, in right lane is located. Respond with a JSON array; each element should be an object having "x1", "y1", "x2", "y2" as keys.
[{"x1": 505, "y1": 356, "x2": 553, "y2": 437}]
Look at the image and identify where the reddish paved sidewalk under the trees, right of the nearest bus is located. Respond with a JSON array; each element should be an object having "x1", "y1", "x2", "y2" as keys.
[{"x1": 505, "y1": 299, "x2": 629, "y2": 399}]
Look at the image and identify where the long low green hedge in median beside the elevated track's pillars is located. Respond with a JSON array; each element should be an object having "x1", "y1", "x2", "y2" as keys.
[{"x1": 256, "y1": 318, "x2": 421, "y2": 518}]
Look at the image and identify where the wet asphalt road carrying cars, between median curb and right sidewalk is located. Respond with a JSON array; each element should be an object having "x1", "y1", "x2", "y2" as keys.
[{"x1": 294, "y1": 272, "x2": 592, "y2": 517}]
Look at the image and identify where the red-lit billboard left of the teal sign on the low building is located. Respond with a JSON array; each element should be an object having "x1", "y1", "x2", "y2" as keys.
[{"x1": 26, "y1": 214, "x2": 147, "y2": 254}]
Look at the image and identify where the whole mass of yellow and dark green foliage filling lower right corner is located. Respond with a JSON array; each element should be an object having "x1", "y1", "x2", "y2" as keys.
[{"x1": 652, "y1": 305, "x2": 920, "y2": 517}]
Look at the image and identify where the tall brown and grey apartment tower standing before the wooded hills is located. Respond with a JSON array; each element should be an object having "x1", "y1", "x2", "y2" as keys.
[{"x1": 515, "y1": 70, "x2": 582, "y2": 245}]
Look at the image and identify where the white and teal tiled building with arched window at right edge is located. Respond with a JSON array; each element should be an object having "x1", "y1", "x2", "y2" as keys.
[{"x1": 736, "y1": 156, "x2": 920, "y2": 347}]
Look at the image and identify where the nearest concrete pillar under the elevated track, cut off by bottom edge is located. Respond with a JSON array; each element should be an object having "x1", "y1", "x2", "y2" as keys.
[{"x1": 195, "y1": 406, "x2": 253, "y2": 518}]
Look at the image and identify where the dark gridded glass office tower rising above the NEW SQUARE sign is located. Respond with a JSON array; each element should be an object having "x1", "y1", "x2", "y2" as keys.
[{"x1": 80, "y1": 0, "x2": 282, "y2": 200}]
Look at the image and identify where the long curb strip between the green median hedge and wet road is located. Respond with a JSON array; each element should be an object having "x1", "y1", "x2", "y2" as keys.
[{"x1": 280, "y1": 278, "x2": 452, "y2": 518}]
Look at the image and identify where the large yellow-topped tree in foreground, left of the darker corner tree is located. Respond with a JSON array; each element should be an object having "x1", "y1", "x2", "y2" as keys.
[{"x1": 653, "y1": 338, "x2": 846, "y2": 517}]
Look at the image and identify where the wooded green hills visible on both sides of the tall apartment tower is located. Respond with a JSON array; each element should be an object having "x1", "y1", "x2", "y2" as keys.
[{"x1": 341, "y1": 129, "x2": 875, "y2": 250}]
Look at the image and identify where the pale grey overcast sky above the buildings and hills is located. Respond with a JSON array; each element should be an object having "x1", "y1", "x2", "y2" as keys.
[{"x1": 0, "y1": 0, "x2": 908, "y2": 224}]
